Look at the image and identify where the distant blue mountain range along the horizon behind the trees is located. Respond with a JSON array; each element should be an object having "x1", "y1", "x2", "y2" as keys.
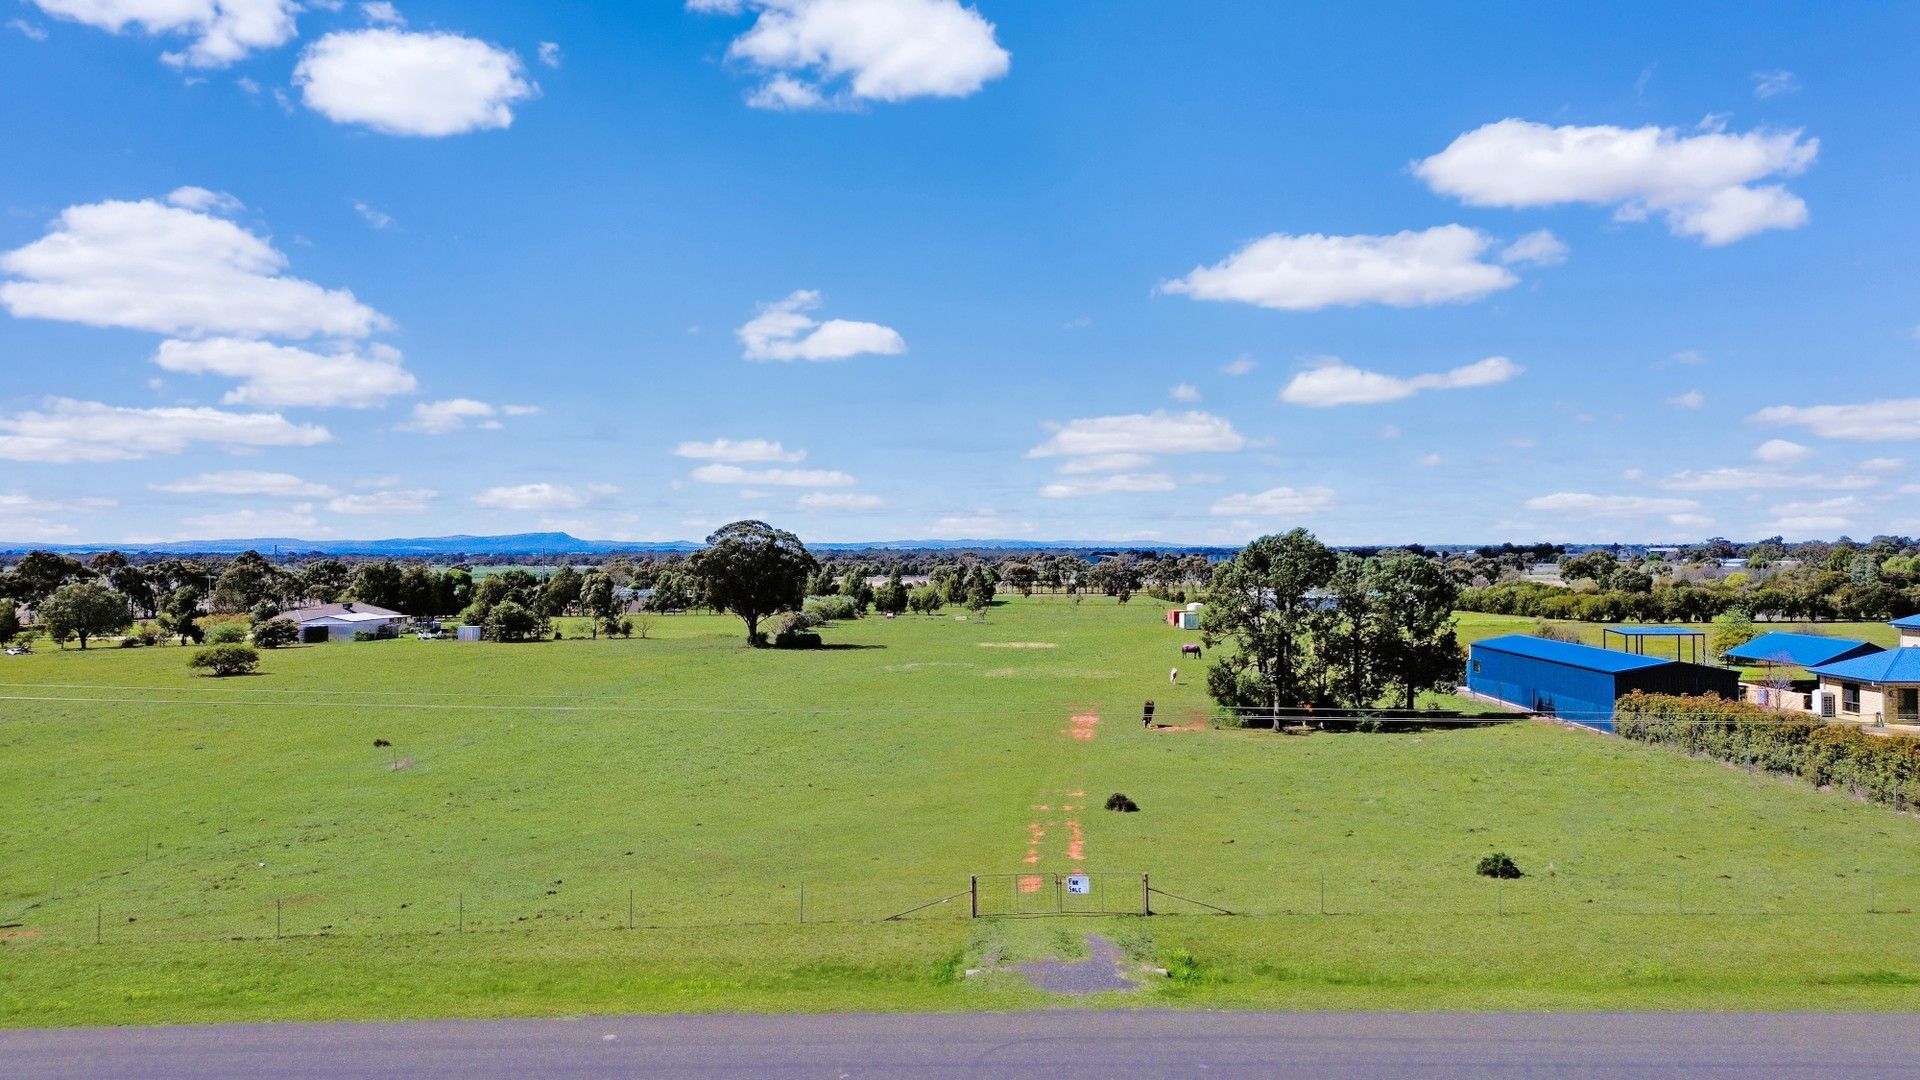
[{"x1": 0, "y1": 532, "x2": 1221, "y2": 559}]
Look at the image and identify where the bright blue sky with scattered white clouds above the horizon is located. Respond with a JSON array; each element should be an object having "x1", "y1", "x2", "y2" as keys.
[{"x1": 0, "y1": 0, "x2": 1920, "y2": 544}]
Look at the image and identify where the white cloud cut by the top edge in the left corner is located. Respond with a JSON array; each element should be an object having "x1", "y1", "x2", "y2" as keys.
[{"x1": 31, "y1": 0, "x2": 300, "y2": 67}]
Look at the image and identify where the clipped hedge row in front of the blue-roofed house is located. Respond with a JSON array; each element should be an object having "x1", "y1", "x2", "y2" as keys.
[{"x1": 1615, "y1": 694, "x2": 1920, "y2": 809}]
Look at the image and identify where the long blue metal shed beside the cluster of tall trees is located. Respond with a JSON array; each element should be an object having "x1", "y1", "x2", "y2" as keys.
[{"x1": 1467, "y1": 634, "x2": 1740, "y2": 732}]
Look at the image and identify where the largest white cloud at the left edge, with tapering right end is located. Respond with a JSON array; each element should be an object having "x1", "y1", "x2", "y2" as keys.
[{"x1": 0, "y1": 188, "x2": 386, "y2": 338}]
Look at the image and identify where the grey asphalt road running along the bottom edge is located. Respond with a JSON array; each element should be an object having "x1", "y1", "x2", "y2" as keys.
[{"x1": 0, "y1": 1013, "x2": 1920, "y2": 1080}]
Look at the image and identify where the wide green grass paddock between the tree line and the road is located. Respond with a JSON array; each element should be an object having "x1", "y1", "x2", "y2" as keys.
[{"x1": 0, "y1": 598, "x2": 1920, "y2": 1026}]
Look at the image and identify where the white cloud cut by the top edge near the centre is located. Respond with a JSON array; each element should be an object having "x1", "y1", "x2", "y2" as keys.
[{"x1": 687, "y1": 0, "x2": 1010, "y2": 110}]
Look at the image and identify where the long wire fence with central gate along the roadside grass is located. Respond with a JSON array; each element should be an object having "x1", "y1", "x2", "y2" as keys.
[{"x1": 15, "y1": 867, "x2": 1920, "y2": 945}]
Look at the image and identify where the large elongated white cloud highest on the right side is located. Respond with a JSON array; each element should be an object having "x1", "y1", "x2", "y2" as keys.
[{"x1": 1413, "y1": 119, "x2": 1820, "y2": 246}]
